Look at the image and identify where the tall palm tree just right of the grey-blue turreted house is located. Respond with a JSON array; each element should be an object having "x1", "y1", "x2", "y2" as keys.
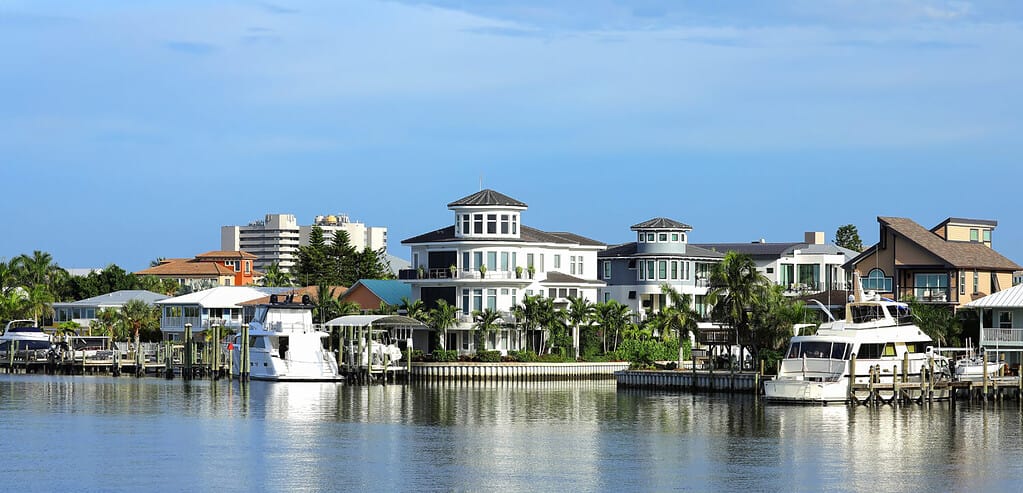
[{"x1": 707, "y1": 252, "x2": 770, "y2": 360}]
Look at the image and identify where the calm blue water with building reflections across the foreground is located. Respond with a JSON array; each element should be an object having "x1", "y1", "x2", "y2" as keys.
[{"x1": 0, "y1": 375, "x2": 1023, "y2": 491}]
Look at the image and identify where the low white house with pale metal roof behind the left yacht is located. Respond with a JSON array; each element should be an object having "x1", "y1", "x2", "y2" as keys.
[{"x1": 155, "y1": 286, "x2": 294, "y2": 341}]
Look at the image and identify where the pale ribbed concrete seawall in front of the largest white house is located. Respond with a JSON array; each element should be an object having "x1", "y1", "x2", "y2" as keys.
[{"x1": 410, "y1": 362, "x2": 629, "y2": 382}]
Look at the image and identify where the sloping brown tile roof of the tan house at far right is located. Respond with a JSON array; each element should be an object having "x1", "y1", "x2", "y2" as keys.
[{"x1": 878, "y1": 216, "x2": 1021, "y2": 271}]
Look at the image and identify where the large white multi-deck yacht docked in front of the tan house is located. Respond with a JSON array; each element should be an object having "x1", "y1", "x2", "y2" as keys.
[{"x1": 764, "y1": 276, "x2": 947, "y2": 402}]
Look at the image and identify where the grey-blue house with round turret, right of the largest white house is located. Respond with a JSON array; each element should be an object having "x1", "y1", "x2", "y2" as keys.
[{"x1": 598, "y1": 218, "x2": 724, "y2": 316}]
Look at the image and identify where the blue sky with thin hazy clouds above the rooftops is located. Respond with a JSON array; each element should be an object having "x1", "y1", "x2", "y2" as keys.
[{"x1": 0, "y1": 0, "x2": 1023, "y2": 270}]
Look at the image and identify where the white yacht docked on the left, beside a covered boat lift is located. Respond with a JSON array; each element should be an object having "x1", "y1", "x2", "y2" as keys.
[{"x1": 230, "y1": 295, "x2": 341, "y2": 382}]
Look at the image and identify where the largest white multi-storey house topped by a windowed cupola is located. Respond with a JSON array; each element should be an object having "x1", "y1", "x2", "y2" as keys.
[{"x1": 399, "y1": 189, "x2": 606, "y2": 353}]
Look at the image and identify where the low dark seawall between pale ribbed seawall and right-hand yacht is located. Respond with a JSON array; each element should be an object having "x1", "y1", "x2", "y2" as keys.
[{"x1": 615, "y1": 369, "x2": 762, "y2": 394}]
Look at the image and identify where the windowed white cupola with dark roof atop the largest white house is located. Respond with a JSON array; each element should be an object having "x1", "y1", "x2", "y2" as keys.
[{"x1": 448, "y1": 188, "x2": 527, "y2": 238}]
